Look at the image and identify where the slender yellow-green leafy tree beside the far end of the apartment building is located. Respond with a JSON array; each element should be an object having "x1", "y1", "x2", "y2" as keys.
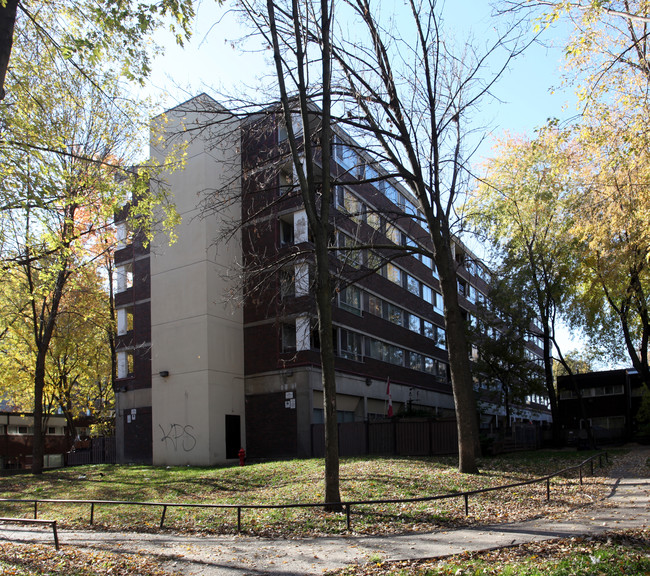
[{"x1": 470, "y1": 126, "x2": 577, "y2": 438}]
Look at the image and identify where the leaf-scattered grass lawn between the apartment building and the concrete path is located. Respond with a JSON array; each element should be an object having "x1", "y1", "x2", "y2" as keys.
[{"x1": 0, "y1": 451, "x2": 609, "y2": 536}]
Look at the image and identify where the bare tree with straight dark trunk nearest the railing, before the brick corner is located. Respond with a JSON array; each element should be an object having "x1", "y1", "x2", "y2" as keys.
[{"x1": 235, "y1": 0, "x2": 341, "y2": 510}]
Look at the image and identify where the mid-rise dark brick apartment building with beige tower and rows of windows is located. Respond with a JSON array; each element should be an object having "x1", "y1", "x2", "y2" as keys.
[{"x1": 115, "y1": 95, "x2": 543, "y2": 465}]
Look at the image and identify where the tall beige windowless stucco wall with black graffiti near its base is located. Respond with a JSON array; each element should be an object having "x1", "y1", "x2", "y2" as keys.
[{"x1": 151, "y1": 97, "x2": 245, "y2": 466}]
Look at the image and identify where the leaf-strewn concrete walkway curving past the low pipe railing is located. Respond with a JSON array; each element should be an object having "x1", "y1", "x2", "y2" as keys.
[{"x1": 0, "y1": 447, "x2": 650, "y2": 576}]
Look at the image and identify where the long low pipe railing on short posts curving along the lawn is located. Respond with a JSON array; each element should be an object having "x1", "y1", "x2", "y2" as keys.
[{"x1": 0, "y1": 452, "x2": 609, "y2": 533}]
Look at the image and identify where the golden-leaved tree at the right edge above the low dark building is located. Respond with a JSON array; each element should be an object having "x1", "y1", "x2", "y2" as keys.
[{"x1": 560, "y1": 105, "x2": 650, "y2": 384}]
